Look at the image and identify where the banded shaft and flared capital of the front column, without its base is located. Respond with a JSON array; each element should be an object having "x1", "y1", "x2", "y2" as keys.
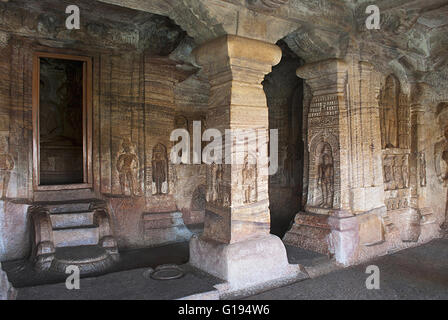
[{"x1": 195, "y1": 35, "x2": 281, "y2": 244}]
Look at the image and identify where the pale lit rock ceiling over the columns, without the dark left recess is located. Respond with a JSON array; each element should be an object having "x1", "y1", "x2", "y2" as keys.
[{"x1": 93, "y1": 0, "x2": 448, "y2": 95}]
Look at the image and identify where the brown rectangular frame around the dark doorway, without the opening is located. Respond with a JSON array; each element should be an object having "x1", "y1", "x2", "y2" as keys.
[{"x1": 33, "y1": 52, "x2": 93, "y2": 191}]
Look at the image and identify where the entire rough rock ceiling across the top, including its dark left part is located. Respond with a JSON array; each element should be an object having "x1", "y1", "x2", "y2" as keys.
[{"x1": 0, "y1": 0, "x2": 448, "y2": 91}]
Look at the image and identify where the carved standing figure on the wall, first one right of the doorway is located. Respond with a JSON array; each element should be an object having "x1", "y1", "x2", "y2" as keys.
[{"x1": 117, "y1": 139, "x2": 141, "y2": 196}]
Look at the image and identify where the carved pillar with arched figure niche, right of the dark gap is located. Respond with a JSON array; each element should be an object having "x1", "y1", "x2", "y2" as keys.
[{"x1": 284, "y1": 59, "x2": 385, "y2": 264}]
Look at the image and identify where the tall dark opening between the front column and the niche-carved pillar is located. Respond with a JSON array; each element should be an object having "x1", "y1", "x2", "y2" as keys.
[{"x1": 263, "y1": 41, "x2": 304, "y2": 237}]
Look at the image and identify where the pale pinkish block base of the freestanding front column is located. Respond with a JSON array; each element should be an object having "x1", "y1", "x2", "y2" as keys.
[{"x1": 189, "y1": 235, "x2": 303, "y2": 290}]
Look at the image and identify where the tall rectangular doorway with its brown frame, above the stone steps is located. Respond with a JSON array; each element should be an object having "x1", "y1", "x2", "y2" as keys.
[{"x1": 33, "y1": 53, "x2": 92, "y2": 190}]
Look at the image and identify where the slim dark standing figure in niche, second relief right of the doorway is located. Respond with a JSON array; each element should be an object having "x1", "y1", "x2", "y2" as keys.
[{"x1": 152, "y1": 143, "x2": 169, "y2": 195}]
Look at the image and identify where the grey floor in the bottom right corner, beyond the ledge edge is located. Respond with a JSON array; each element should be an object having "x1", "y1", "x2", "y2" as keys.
[{"x1": 246, "y1": 239, "x2": 448, "y2": 300}]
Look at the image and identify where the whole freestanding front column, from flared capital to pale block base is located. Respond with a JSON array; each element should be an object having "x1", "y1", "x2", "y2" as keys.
[{"x1": 190, "y1": 35, "x2": 299, "y2": 288}]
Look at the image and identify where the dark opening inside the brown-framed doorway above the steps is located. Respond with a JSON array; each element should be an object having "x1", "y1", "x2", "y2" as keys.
[{"x1": 39, "y1": 58, "x2": 84, "y2": 185}]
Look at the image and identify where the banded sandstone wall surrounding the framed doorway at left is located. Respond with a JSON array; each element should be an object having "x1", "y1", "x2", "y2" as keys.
[{"x1": 0, "y1": 1, "x2": 206, "y2": 261}]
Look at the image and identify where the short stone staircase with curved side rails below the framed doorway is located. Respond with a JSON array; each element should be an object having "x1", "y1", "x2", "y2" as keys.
[{"x1": 30, "y1": 199, "x2": 119, "y2": 274}]
